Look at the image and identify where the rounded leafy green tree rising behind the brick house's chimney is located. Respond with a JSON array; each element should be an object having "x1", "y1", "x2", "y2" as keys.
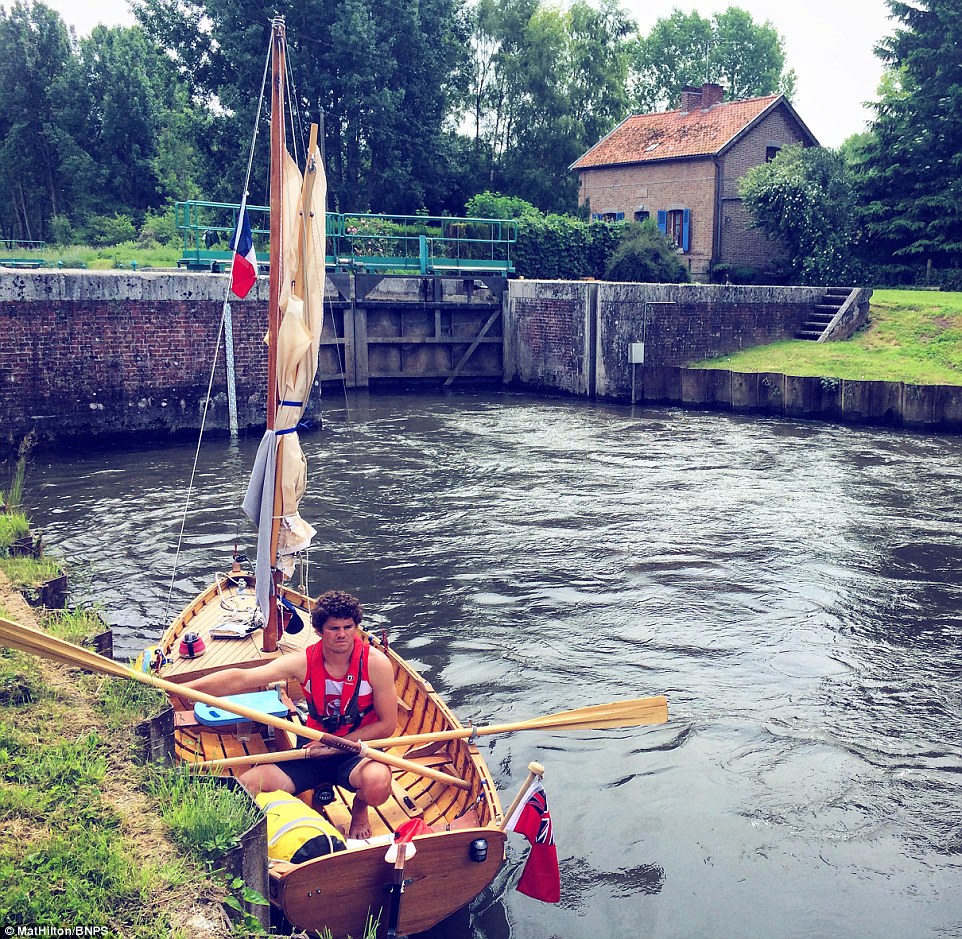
[{"x1": 632, "y1": 7, "x2": 796, "y2": 111}]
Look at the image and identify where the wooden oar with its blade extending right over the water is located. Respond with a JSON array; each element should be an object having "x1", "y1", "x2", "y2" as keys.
[{"x1": 193, "y1": 695, "x2": 668, "y2": 769}]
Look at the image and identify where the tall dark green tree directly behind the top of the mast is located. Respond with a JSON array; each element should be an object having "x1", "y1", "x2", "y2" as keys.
[{"x1": 133, "y1": 0, "x2": 467, "y2": 212}]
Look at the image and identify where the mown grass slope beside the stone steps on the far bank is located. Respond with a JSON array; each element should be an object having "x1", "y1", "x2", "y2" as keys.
[{"x1": 691, "y1": 290, "x2": 962, "y2": 385}]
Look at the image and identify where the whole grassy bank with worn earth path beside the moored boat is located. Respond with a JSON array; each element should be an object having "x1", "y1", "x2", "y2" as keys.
[{"x1": 0, "y1": 466, "x2": 256, "y2": 939}]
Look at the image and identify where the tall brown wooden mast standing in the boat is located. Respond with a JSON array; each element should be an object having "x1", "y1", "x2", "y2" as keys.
[{"x1": 264, "y1": 16, "x2": 287, "y2": 652}]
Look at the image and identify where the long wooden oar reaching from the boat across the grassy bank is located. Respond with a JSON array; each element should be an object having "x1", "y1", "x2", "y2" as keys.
[{"x1": 0, "y1": 618, "x2": 471, "y2": 789}]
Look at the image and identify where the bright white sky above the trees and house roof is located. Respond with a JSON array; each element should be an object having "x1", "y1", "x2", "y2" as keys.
[{"x1": 47, "y1": 0, "x2": 894, "y2": 147}]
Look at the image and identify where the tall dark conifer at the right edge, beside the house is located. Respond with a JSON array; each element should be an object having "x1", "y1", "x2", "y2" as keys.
[{"x1": 857, "y1": 0, "x2": 962, "y2": 266}]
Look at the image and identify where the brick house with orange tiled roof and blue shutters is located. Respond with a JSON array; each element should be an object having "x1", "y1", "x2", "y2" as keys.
[{"x1": 570, "y1": 83, "x2": 818, "y2": 281}]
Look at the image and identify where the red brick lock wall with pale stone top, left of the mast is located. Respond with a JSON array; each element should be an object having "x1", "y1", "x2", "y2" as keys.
[{"x1": 0, "y1": 272, "x2": 267, "y2": 444}]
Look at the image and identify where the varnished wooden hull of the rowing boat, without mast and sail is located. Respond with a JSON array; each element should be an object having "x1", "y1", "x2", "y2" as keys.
[{"x1": 161, "y1": 572, "x2": 506, "y2": 937}]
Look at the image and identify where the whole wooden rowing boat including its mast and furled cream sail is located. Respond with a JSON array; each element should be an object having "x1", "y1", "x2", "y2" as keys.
[{"x1": 149, "y1": 17, "x2": 506, "y2": 937}]
